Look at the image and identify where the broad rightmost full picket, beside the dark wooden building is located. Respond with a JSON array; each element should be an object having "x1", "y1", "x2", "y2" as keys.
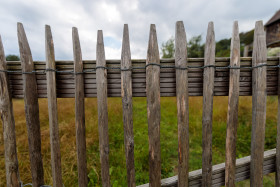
[{"x1": 250, "y1": 21, "x2": 267, "y2": 186}]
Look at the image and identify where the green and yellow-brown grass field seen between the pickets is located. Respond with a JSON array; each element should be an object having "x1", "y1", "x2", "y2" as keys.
[{"x1": 0, "y1": 97, "x2": 277, "y2": 187}]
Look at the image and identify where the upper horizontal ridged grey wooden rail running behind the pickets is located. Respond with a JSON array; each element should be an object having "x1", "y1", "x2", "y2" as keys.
[{"x1": 7, "y1": 57, "x2": 280, "y2": 98}]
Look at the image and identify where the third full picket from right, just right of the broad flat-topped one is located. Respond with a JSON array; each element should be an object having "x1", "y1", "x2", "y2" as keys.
[{"x1": 202, "y1": 22, "x2": 215, "y2": 187}]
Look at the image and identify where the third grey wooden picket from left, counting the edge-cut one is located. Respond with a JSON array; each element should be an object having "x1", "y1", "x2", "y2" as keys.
[{"x1": 45, "y1": 25, "x2": 63, "y2": 187}]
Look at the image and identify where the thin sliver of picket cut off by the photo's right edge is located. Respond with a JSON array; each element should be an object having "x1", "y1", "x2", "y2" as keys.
[{"x1": 275, "y1": 53, "x2": 280, "y2": 187}]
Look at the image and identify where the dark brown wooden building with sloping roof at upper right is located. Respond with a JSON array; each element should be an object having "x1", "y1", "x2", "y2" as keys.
[{"x1": 265, "y1": 9, "x2": 280, "y2": 48}]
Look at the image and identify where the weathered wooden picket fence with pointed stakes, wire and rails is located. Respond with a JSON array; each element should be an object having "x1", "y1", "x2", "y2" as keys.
[{"x1": 0, "y1": 21, "x2": 280, "y2": 187}]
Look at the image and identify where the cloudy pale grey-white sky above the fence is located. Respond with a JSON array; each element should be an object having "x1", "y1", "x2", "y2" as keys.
[{"x1": 0, "y1": 0, "x2": 280, "y2": 60}]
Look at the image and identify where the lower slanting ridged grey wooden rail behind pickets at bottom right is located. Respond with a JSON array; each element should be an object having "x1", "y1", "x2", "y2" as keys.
[{"x1": 138, "y1": 149, "x2": 276, "y2": 187}]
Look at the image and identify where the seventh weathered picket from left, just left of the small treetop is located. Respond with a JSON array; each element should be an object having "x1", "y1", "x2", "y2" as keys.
[{"x1": 146, "y1": 24, "x2": 161, "y2": 187}]
